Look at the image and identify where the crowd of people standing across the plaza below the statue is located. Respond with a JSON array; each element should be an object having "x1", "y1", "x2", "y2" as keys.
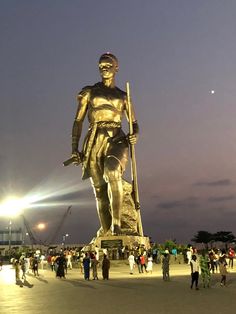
[{"x1": 1, "y1": 246, "x2": 235, "y2": 290}]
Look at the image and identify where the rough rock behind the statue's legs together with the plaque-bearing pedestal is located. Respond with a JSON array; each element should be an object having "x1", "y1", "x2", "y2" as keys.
[{"x1": 85, "y1": 180, "x2": 150, "y2": 249}]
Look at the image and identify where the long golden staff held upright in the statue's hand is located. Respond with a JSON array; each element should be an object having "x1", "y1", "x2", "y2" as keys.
[{"x1": 126, "y1": 82, "x2": 143, "y2": 236}]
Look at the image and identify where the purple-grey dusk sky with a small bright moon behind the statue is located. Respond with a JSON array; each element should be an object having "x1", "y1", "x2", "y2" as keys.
[{"x1": 0, "y1": 0, "x2": 236, "y2": 243}]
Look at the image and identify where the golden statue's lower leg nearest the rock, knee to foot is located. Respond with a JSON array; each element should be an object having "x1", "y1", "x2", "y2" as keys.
[{"x1": 104, "y1": 156, "x2": 123, "y2": 234}]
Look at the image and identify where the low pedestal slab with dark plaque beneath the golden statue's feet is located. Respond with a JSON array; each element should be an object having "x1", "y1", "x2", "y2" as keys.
[{"x1": 90, "y1": 235, "x2": 150, "y2": 250}]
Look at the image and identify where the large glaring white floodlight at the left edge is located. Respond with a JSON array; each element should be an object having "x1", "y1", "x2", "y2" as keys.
[{"x1": 0, "y1": 198, "x2": 25, "y2": 217}]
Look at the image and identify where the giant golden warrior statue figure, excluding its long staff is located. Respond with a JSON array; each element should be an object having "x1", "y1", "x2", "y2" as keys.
[{"x1": 64, "y1": 53, "x2": 142, "y2": 236}]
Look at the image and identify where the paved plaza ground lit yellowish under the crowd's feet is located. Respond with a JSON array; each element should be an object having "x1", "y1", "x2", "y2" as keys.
[{"x1": 0, "y1": 263, "x2": 236, "y2": 314}]
